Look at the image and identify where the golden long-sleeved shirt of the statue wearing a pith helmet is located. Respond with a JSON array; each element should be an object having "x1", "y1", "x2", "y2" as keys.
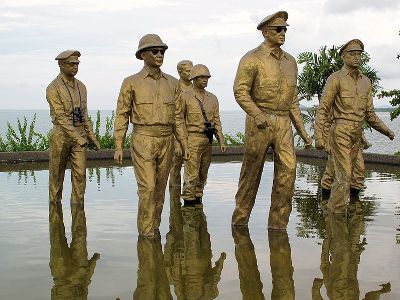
[{"x1": 114, "y1": 67, "x2": 183, "y2": 149}]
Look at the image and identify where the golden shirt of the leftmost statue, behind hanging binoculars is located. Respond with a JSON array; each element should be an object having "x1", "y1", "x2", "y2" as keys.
[{"x1": 46, "y1": 74, "x2": 94, "y2": 145}]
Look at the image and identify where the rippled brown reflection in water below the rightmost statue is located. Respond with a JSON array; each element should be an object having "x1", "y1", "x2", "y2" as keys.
[{"x1": 312, "y1": 201, "x2": 390, "y2": 300}]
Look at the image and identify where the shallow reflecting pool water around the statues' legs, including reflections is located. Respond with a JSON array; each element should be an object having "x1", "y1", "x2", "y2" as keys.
[{"x1": 0, "y1": 160, "x2": 400, "y2": 300}]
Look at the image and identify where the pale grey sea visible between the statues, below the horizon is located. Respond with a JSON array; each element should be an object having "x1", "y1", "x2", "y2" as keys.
[{"x1": 0, "y1": 110, "x2": 400, "y2": 154}]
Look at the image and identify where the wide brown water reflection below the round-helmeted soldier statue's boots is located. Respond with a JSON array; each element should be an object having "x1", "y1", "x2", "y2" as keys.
[{"x1": 164, "y1": 188, "x2": 226, "y2": 299}]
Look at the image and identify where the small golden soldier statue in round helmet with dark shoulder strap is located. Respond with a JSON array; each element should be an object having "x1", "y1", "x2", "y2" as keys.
[{"x1": 176, "y1": 64, "x2": 226, "y2": 205}]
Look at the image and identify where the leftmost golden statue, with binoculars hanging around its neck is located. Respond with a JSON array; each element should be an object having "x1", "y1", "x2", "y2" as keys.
[{"x1": 46, "y1": 50, "x2": 100, "y2": 203}]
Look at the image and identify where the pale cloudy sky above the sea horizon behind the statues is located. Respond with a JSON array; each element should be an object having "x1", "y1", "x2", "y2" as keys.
[{"x1": 0, "y1": 0, "x2": 400, "y2": 110}]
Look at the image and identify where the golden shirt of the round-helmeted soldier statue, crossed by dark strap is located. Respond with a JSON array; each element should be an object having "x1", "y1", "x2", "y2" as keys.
[{"x1": 177, "y1": 88, "x2": 224, "y2": 144}]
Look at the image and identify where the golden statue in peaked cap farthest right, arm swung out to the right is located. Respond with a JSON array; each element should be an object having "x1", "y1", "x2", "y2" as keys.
[{"x1": 315, "y1": 39, "x2": 394, "y2": 213}]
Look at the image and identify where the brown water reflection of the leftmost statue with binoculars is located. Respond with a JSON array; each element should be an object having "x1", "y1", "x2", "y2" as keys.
[{"x1": 49, "y1": 203, "x2": 100, "y2": 300}]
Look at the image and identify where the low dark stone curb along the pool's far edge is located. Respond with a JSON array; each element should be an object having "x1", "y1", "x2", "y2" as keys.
[{"x1": 0, "y1": 146, "x2": 400, "y2": 166}]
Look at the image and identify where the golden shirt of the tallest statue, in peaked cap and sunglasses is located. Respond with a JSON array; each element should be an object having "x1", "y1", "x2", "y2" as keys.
[{"x1": 233, "y1": 43, "x2": 307, "y2": 137}]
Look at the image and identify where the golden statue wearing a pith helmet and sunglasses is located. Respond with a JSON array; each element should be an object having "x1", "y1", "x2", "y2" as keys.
[{"x1": 114, "y1": 34, "x2": 188, "y2": 236}]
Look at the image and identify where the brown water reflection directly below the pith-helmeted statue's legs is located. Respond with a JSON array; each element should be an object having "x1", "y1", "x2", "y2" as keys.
[{"x1": 133, "y1": 230, "x2": 172, "y2": 300}]
